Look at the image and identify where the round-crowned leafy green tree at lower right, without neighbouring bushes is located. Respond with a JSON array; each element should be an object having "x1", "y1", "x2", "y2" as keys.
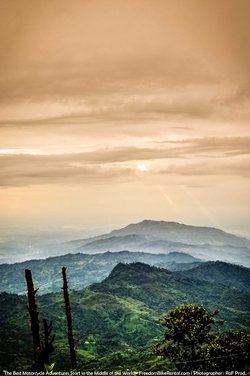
[{"x1": 156, "y1": 304, "x2": 222, "y2": 368}]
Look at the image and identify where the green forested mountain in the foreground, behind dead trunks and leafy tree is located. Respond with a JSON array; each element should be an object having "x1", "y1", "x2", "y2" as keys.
[{"x1": 0, "y1": 262, "x2": 250, "y2": 370}]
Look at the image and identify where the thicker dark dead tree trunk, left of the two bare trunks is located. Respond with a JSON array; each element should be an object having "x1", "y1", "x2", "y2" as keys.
[{"x1": 25, "y1": 269, "x2": 41, "y2": 362}]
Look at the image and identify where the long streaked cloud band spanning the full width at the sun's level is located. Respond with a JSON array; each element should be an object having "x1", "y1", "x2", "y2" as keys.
[{"x1": 0, "y1": 137, "x2": 250, "y2": 186}]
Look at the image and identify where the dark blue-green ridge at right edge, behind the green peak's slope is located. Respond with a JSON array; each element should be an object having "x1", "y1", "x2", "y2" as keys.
[{"x1": 181, "y1": 261, "x2": 250, "y2": 291}]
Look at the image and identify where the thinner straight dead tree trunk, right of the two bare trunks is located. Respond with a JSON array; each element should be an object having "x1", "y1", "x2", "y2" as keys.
[{"x1": 62, "y1": 267, "x2": 76, "y2": 369}]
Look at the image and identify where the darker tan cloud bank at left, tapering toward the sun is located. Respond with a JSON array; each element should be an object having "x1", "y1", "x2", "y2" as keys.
[{"x1": 0, "y1": 156, "x2": 135, "y2": 187}]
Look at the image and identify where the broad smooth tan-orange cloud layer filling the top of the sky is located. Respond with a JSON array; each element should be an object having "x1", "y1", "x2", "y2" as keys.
[{"x1": 0, "y1": 0, "x2": 250, "y2": 131}]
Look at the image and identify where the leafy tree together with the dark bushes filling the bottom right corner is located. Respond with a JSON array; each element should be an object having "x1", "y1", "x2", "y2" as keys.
[{"x1": 155, "y1": 304, "x2": 250, "y2": 371}]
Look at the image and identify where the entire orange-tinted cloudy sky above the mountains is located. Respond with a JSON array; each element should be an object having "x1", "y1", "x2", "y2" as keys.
[{"x1": 0, "y1": 0, "x2": 250, "y2": 237}]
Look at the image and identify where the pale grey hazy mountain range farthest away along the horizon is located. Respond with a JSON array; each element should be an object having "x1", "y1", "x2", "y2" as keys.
[{"x1": 0, "y1": 220, "x2": 250, "y2": 267}]
